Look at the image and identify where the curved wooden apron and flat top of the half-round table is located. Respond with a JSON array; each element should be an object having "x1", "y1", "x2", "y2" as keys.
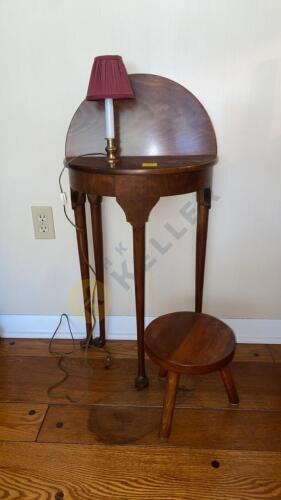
[{"x1": 68, "y1": 156, "x2": 214, "y2": 198}]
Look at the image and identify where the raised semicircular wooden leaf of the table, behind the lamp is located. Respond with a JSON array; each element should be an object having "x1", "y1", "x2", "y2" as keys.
[{"x1": 66, "y1": 74, "x2": 217, "y2": 157}]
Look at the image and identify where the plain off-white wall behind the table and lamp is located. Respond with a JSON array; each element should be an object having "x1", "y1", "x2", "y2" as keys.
[{"x1": 0, "y1": 0, "x2": 281, "y2": 319}]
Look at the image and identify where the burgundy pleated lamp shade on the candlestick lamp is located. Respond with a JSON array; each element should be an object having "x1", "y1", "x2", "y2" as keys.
[{"x1": 86, "y1": 56, "x2": 134, "y2": 101}]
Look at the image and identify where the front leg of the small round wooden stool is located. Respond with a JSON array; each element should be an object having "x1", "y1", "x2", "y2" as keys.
[{"x1": 159, "y1": 372, "x2": 179, "y2": 438}]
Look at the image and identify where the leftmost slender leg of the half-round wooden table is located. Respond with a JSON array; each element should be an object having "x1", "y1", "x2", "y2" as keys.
[{"x1": 71, "y1": 189, "x2": 92, "y2": 339}]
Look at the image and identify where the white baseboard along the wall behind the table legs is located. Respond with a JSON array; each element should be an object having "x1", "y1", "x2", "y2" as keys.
[{"x1": 0, "y1": 314, "x2": 281, "y2": 344}]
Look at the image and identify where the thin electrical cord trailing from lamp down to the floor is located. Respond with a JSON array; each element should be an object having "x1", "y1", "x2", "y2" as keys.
[{"x1": 47, "y1": 153, "x2": 112, "y2": 403}]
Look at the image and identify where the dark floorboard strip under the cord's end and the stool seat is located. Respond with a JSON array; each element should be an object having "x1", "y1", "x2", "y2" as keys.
[{"x1": 0, "y1": 357, "x2": 281, "y2": 409}]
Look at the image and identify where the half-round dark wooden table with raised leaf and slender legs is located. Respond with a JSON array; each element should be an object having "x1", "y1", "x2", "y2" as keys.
[{"x1": 65, "y1": 75, "x2": 217, "y2": 388}]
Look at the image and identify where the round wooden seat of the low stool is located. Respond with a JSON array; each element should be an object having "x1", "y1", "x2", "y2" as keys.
[{"x1": 144, "y1": 312, "x2": 235, "y2": 373}]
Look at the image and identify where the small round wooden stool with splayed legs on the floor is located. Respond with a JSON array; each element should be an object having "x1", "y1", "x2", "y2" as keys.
[{"x1": 144, "y1": 312, "x2": 239, "y2": 438}]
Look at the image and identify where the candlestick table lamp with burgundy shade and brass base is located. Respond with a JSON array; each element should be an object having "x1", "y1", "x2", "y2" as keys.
[{"x1": 86, "y1": 56, "x2": 134, "y2": 167}]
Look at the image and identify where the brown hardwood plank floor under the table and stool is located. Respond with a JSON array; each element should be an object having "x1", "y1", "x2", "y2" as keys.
[{"x1": 0, "y1": 339, "x2": 281, "y2": 500}]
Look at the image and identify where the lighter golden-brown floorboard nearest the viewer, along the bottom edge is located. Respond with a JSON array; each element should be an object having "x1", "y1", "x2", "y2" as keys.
[{"x1": 0, "y1": 443, "x2": 281, "y2": 500}]
